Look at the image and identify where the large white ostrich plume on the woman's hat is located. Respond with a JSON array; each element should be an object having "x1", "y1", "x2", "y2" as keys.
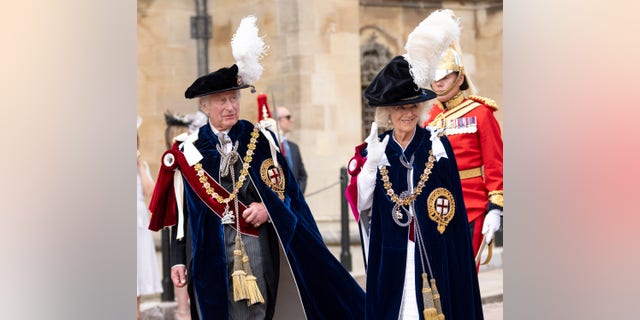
[{"x1": 404, "y1": 9, "x2": 460, "y2": 88}]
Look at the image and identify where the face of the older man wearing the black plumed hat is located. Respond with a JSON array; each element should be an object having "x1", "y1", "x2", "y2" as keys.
[{"x1": 200, "y1": 90, "x2": 240, "y2": 131}]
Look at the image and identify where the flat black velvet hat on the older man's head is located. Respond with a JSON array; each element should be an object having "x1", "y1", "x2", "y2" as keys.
[{"x1": 184, "y1": 64, "x2": 250, "y2": 99}]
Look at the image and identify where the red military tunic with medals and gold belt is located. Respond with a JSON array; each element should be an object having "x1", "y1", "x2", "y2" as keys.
[{"x1": 424, "y1": 96, "x2": 503, "y2": 255}]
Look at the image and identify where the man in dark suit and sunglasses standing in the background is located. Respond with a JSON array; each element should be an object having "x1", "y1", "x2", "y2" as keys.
[{"x1": 277, "y1": 107, "x2": 307, "y2": 194}]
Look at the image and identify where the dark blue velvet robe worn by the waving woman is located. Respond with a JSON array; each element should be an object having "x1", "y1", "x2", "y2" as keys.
[{"x1": 365, "y1": 127, "x2": 483, "y2": 320}]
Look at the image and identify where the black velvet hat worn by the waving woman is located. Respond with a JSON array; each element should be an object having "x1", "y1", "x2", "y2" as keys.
[{"x1": 364, "y1": 56, "x2": 436, "y2": 107}]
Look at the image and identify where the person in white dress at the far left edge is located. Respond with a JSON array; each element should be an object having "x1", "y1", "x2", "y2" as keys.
[{"x1": 136, "y1": 117, "x2": 162, "y2": 319}]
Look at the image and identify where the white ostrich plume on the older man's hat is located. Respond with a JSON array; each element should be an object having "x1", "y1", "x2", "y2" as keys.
[{"x1": 231, "y1": 16, "x2": 268, "y2": 84}]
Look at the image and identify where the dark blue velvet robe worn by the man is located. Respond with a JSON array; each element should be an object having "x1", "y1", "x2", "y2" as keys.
[{"x1": 185, "y1": 120, "x2": 365, "y2": 319}]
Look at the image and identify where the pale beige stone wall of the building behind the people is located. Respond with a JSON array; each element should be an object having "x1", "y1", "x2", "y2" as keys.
[{"x1": 137, "y1": 0, "x2": 502, "y2": 230}]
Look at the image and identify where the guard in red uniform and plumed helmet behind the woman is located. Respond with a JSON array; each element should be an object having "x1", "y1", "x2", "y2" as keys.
[{"x1": 424, "y1": 10, "x2": 503, "y2": 256}]
